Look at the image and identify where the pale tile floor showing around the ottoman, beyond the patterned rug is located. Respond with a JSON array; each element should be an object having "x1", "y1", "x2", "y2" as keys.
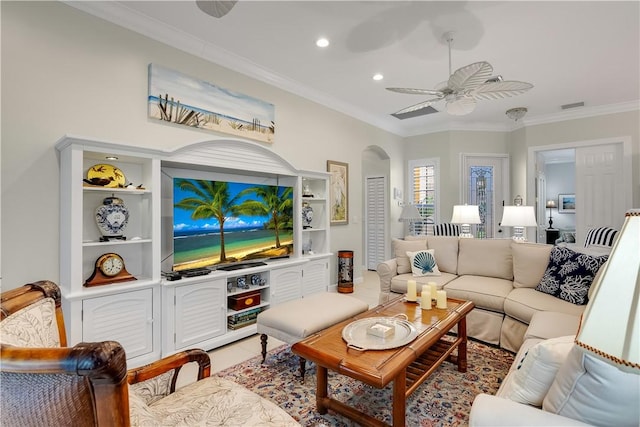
[{"x1": 209, "y1": 271, "x2": 380, "y2": 373}]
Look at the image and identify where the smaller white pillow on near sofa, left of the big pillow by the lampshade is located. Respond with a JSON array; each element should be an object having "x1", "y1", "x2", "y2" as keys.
[{"x1": 500, "y1": 335, "x2": 575, "y2": 407}]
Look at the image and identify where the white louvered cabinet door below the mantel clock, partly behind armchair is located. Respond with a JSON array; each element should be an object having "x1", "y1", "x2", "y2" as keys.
[{"x1": 82, "y1": 288, "x2": 154, "y2": 359}]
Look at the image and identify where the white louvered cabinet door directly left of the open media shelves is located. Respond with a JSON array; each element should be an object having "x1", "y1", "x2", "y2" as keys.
[{"x1": 174, "y1": 280, "x2": 226, "y2": 350}]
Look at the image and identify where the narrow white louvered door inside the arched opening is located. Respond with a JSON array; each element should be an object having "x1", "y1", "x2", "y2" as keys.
[{"x1": 365, "y1": 176, "x2": 387, "y2": 270}]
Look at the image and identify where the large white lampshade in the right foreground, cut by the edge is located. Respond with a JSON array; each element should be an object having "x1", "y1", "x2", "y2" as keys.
[{"x1": 576, "y1": 209, "x2": 640, "y2": 374}]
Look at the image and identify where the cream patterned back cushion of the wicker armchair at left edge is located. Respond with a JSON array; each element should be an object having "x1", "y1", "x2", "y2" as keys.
[{"x1": 0, "y1": 298, "x2": 60, "y2": 348}]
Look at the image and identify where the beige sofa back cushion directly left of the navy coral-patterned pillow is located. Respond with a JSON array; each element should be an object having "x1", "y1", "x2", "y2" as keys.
[{"x1": 511, "y1": 243, "x2": 553, "y2": 288}]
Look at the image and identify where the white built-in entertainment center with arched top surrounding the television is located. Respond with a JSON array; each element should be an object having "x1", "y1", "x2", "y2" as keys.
[{"x1": 56, "y1": 136, "x2": 332, "y2": 367}]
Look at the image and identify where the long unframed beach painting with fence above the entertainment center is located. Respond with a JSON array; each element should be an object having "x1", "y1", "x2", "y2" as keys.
[{"x1": 148, "y1": 64, "x2": 276, "y2": 143}]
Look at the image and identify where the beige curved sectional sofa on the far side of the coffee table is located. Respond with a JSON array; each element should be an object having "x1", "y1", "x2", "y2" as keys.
[{"x1": 377, "y1": 236, "x2": 600, "y2": 352}]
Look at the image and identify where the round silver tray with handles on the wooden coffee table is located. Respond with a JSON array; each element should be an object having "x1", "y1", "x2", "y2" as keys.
[{"x1": 342, "y1": 317, "x2": 418, "y2": 351}]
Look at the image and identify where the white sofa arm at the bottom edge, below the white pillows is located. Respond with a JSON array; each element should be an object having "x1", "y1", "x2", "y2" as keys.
[{"x1": 469, "y1": 394, "x2": 589, "y2": 427}]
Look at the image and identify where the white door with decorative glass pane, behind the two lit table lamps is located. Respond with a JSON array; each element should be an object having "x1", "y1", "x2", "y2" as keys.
[{"x1": 461, "y1": 154, "x2": 508, "y2": 238}]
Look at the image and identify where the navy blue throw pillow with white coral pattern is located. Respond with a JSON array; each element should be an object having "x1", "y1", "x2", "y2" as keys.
[{"x1": 536, "y1": 246, "x2": 609, "y2": 305}]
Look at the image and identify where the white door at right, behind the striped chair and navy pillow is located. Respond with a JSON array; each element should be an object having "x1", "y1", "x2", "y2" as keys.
[{"x1": 576, "y1": 144, "x2": 627, "y2": 243}]
